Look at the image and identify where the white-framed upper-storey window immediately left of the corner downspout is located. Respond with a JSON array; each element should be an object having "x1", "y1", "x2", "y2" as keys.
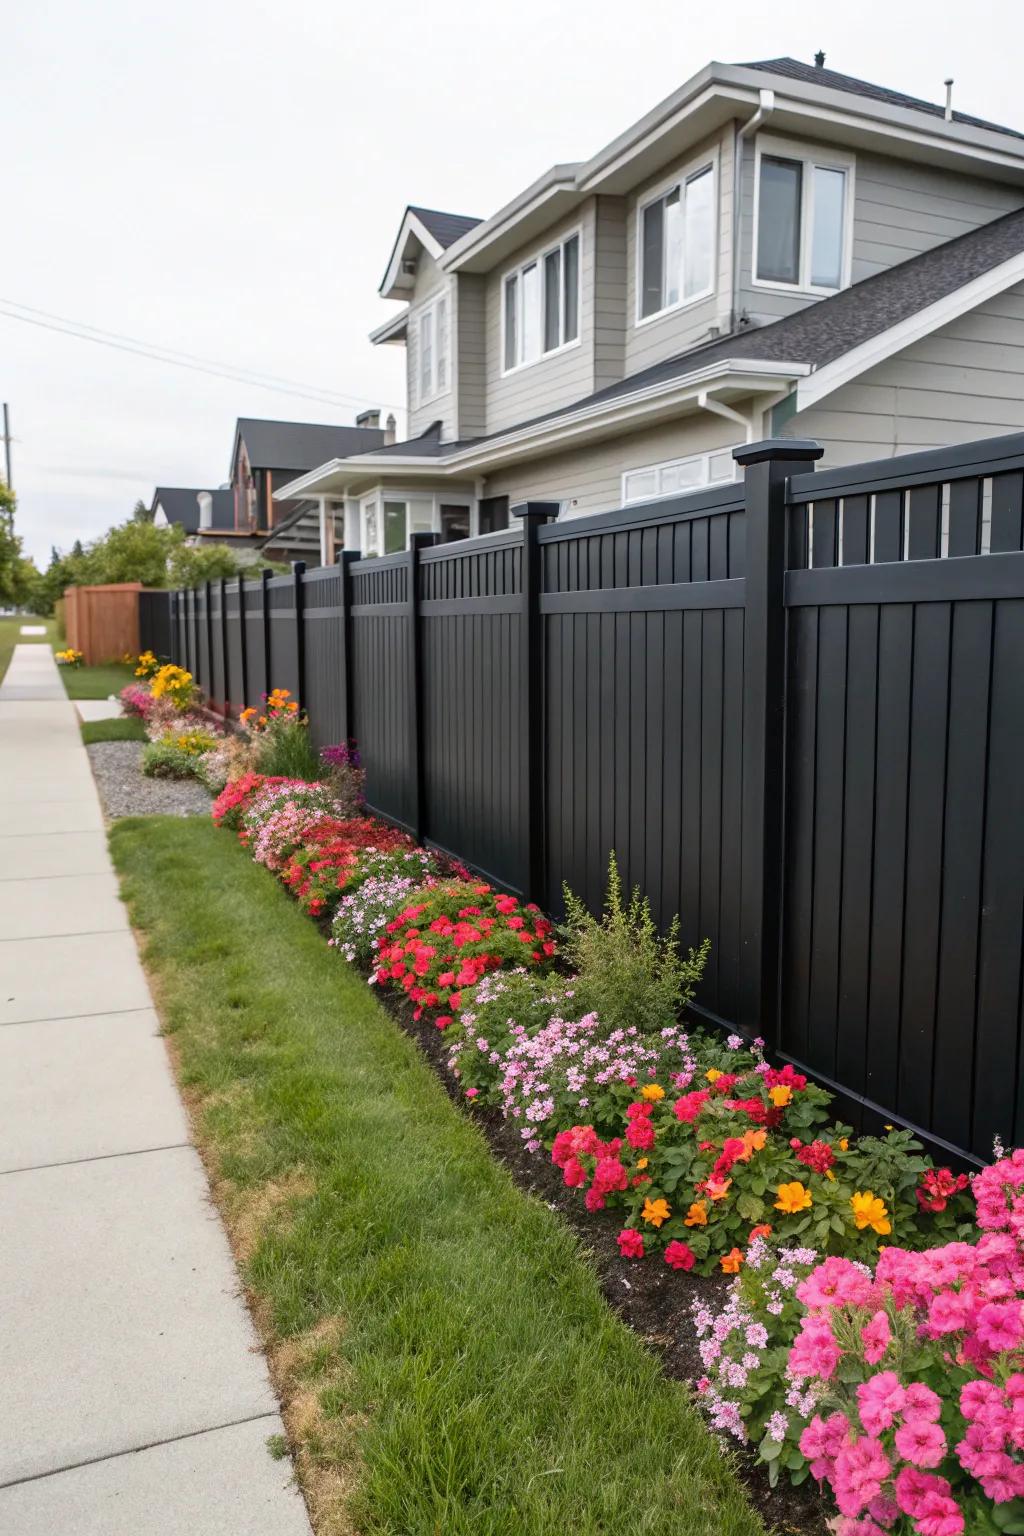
[{"x1": 639, "y1": 166, "x2": 715, "y2": 319}]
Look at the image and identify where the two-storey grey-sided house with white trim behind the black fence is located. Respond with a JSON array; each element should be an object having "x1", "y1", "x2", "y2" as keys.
[{"x1": 276, "y1": 54, "x2": 1024, "y2": 554}]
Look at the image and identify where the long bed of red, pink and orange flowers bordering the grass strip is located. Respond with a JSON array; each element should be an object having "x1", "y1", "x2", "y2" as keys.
[{"x1": 202, "y1": 755, "x2": 1007, "y2": 1536}]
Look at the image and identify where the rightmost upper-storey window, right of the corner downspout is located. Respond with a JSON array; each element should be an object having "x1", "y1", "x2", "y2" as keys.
[{"x1": 755, "y1": 140, "x2": 854, "y2": 293}]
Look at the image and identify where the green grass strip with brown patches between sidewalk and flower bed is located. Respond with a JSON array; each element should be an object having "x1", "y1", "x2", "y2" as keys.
[{"x1": 111, "y1": 817, "x2": 763, "y2": 1536}]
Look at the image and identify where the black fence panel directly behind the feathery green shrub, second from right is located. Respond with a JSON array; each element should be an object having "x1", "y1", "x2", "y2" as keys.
[{"x1": 536, "y1": 487, "x2": 745, "y2": 1018}]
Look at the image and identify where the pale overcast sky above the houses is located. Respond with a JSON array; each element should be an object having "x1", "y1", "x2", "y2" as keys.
[{"x1": 0, "y1": 0, "x2": 1024, "y2": 564}]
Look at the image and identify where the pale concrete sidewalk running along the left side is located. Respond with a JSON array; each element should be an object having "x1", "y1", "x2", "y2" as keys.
[{"x1": 0, "y1": 645, "x2": 310, "y2": 1536}]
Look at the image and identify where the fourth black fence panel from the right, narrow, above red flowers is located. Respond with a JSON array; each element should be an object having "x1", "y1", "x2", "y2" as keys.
[{"x1": 352, "y1": 554, "x2": 416, "y2": 828}]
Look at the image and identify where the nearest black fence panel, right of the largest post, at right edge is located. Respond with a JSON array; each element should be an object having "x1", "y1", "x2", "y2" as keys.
[{"x1": 780, "y1": 439, "x2": 1024, "y2": 1158}]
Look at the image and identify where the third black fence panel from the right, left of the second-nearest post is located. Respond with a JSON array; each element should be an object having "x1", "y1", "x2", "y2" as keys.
[{"x1": 418, "y1": 528, "x2": 527, "y2": 891}]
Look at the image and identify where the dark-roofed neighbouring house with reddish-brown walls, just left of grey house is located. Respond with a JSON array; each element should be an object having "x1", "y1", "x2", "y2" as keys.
[{"x1": 230, "y1": 410, "x2": 395, "y2": 559}]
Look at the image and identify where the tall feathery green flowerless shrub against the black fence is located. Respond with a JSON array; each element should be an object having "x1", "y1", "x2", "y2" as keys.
[{"x1": 560, "y1": 851, "x2": 711, "y2": 1032}]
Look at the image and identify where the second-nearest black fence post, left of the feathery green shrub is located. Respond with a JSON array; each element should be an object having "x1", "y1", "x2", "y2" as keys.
[{"x1": 511, "y1": 501, "x2": 560, "y2": 906}]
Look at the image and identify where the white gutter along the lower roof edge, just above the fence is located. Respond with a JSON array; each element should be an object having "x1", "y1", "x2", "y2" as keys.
[{"x1": 273, "y1": 358, "x2": 811, "y2": 501}]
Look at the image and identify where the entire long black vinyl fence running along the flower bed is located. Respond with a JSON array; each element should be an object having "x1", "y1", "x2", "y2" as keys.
[{"x1": 142, "y1": 435, "x2": 1024, "y2": 1158}]
